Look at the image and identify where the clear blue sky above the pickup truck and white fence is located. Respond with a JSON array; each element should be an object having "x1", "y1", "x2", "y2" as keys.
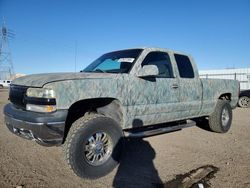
[{"x1": 0, "y1": 0, "x2": 250, "y2": 74}]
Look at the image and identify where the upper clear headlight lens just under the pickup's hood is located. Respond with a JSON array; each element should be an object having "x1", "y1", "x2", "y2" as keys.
[{"x1": 26, "y1": 88, "x2": 56, "y2": 98}]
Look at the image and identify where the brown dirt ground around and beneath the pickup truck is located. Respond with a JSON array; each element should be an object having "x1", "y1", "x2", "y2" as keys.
[{"x1": 0, "y1": 90, "x2": 250, "y2": 188}]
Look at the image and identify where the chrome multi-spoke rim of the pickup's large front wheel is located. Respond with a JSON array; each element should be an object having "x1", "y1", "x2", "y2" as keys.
[{"x1": 84, "y1": 132, "x2": 113, "y2": 166}]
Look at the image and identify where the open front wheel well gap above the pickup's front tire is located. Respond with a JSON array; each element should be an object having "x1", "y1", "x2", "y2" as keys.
[{"x1": 63, "y1": 98, "x2": 123, "y2": 142}]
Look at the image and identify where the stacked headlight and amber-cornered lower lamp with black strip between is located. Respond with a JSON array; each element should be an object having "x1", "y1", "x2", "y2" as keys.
[{"x1": 26, "y1": 88, "x2": 56, "y2": 112}]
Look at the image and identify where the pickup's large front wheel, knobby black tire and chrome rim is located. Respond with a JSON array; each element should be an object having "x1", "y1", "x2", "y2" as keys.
[{"x1": 63, "y1": 114, "x2": 123, "y2": 179}]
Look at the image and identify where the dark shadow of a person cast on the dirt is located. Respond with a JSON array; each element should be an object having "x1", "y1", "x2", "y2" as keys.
[{"x1": 113, "y1": 138, "x2": 162, "y2": 188}]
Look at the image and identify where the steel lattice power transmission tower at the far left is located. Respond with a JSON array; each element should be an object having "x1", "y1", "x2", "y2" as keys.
[{"x1": 0, "y1": 18, "x2": 15, "y2": 80}]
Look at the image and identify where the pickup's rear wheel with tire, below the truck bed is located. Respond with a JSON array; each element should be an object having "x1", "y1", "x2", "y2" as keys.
[{"x1": 208, "y1": 99, "x2": 232, "y2": 133}]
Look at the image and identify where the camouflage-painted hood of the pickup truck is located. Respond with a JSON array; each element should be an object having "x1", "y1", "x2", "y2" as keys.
[{"x1": 12, "y1": 72, "x2": 116, "y2": 87}]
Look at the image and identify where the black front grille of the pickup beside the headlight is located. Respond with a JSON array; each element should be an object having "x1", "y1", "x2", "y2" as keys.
[{"x1": 9, "y1": 85, "x2": 28, "y2": 108}]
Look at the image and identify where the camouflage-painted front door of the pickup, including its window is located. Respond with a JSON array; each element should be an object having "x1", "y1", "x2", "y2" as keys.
[{"x1": 132, "y1": 51, "x2": 180, "y2": 125}]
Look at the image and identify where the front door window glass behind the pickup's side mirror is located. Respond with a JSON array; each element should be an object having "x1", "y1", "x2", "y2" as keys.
[{"x1": 142, "y1": 52, "x2": 173, "y2": 78}]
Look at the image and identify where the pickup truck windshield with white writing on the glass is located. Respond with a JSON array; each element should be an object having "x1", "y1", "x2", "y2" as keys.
[{"x1": 82, "y1": 49, "x2": 142, "y2": 73}]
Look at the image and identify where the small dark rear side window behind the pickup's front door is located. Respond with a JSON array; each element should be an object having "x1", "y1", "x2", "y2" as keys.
[{"x1": 174, "y1": 54, "x2": 194, "y2": 78}]
